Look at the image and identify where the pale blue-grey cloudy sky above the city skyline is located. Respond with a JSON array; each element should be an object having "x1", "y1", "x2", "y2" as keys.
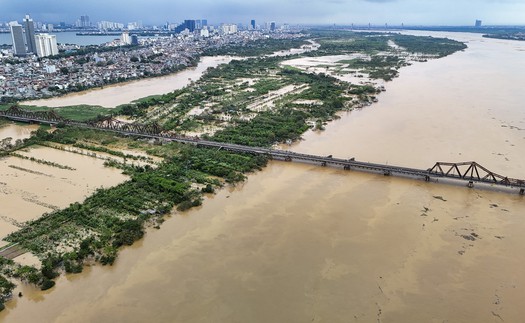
[{"x1": 0, "y1": 0, "x2": 525, "y2": 25}]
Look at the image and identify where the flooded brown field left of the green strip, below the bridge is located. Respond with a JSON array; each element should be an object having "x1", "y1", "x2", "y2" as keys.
[{"x1": 0, "y1": 147, "x2": 127, "y2": 245}]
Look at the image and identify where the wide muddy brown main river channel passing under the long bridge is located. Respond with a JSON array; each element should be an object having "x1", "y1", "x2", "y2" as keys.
[{"x1": 0, "y1": 33, "x2": 525, "y2": 322}]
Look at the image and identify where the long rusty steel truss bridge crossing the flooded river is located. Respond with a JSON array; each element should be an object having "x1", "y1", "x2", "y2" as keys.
[{"x1": 0, "y1": 106, "x2": 525, "y2": 195}]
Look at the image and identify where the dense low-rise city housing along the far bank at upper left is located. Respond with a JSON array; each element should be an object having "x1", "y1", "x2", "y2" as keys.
[{"x1": 0, "y1": 28, "x2": 301, "y2": 102}]
